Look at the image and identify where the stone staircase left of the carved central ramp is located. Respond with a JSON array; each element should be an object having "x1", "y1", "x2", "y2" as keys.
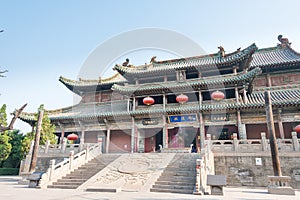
[{"x1": 47, "y1": 154, "x2": 120, "y2": 189}]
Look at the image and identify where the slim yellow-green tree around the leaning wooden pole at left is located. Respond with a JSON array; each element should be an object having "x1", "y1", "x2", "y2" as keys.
[{"x1": 22, "y1": 104, "x2": 56, "y2": 154}]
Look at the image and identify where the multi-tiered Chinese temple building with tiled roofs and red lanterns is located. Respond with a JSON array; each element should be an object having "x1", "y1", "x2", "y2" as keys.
[{"x1": 20, "y1": 37, "x2": 300, "y2": 153}]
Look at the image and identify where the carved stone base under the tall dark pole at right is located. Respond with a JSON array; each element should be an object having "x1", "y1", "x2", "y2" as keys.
[{"x1": 268, "y1": 176, "x2": 295, "y2": 195}]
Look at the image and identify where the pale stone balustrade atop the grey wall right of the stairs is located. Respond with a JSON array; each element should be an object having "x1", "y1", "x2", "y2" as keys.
[{"x1": 210, "y1": 132, "x2": 300, "y2": 153}]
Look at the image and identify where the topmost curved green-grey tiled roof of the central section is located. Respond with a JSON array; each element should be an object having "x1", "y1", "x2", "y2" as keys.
[{"x1": 114, "y1": 44, "x2": 257, "y2": 77}]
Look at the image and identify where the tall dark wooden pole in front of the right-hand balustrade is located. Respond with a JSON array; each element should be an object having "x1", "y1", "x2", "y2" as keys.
[{"x1": 265, "y1": 91, "x2": 282, "y2": 176}]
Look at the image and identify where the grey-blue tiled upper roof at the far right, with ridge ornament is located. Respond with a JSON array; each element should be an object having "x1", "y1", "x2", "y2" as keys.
[{"x1": 250, "y1": 45, "x2": 300, "y2": 70}]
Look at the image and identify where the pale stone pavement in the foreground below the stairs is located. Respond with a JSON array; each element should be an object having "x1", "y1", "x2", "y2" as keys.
[{"x1": 0, "y1": 176, "x2": 300, "y2": 200}]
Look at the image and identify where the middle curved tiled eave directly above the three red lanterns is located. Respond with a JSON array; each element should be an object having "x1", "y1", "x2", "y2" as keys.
[{"x1": 112, "y1": 68, "x2": 261, "y2": 95}]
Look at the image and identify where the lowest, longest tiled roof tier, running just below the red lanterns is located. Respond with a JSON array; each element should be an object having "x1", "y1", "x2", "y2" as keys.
[{"x1": 19, "y1": 85, "x2": 300, "y2": 122}]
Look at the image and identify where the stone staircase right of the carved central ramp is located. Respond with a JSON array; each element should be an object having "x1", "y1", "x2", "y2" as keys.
[{"x1": 150, "y1": 153, "x2": 200, "y2": 194}]
